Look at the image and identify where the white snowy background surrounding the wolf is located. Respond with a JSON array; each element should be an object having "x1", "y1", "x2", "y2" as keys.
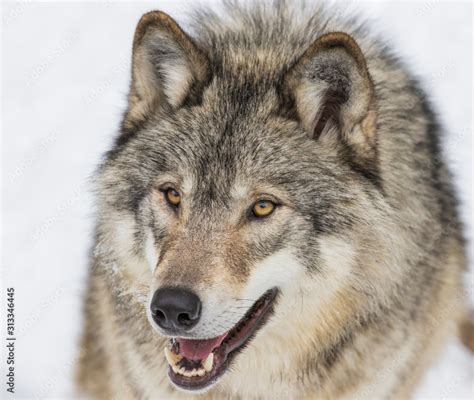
[{"x1": 0, "y1": 1, "x2": 474, "y2": 399}]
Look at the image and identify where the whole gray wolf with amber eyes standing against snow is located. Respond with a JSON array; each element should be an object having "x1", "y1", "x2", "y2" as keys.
[{"x1": 77, "y1": 1, "x2": 466, "y2": 399}]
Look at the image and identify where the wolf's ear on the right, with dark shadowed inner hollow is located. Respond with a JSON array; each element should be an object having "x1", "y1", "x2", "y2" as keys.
[{"x1": 284, "y1": 32, "x2": 375, "y2": 151}]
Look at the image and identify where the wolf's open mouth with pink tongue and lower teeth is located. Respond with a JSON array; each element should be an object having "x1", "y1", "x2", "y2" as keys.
[{"x1": 165, "y1": 288, "x2": 278, "y2": 390}]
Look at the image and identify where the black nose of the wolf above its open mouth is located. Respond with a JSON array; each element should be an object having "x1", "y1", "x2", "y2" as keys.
[{"x1": 151, "y1": 288, "x2": 201, "y2": 332}]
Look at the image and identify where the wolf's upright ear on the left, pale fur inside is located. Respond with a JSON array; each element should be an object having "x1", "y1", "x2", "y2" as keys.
[{"x1": 128, "y1": 11, "x2": 213, "y2": 120}]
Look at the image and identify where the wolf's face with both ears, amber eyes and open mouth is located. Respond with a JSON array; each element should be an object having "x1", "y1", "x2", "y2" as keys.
[{"x1": 96, "y1": 13, "x2": 386, "y2": 390}]
